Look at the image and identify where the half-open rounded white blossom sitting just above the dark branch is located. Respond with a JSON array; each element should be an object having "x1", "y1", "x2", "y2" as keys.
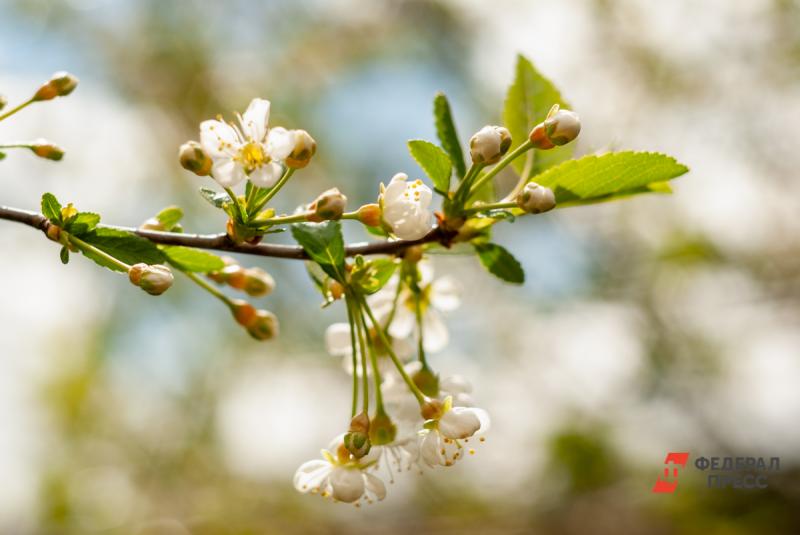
[{"x1": 381, "y1": 173, "x2": 433, "y2": 240}]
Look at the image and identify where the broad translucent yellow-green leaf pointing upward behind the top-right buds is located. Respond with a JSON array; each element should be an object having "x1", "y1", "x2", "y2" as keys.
[{"x1": 503, "y1": 55, "x2": 573, "y2": 176}]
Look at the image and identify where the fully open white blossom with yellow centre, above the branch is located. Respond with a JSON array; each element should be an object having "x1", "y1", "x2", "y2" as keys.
[{"x1": 200, "y1": 98, "x2": 294, "y2": 188}]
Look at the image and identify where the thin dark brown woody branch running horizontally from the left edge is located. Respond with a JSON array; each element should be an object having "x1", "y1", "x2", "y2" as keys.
[{"x1": 0, "y1": 205, "x2": 445, "y2": 260}]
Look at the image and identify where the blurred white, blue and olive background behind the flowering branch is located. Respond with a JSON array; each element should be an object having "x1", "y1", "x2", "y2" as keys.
[{"x1": 0, "y1": 0, "x2": 800, "y2": 535}]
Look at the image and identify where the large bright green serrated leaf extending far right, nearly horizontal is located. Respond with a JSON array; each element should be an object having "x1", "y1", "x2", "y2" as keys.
[{"x1": 533, "y1": 152, "x2": 689, "y2": 207}]
